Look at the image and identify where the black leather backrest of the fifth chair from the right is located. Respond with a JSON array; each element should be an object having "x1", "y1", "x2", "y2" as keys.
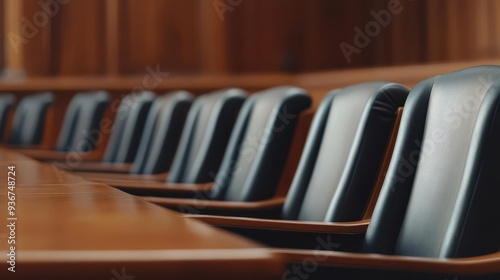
[{"x1": 131, "y1": 91, "x2": 193, "y2": 174}]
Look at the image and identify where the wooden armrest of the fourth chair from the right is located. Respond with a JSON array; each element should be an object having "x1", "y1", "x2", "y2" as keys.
[{"x1": 109, "y1": 182, "x2": 213, "y2": 198}]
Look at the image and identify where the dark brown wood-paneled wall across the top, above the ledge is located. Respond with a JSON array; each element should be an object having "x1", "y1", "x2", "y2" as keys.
[{"x1": 0, "y1": 0, "x2": 500, "y2": 77}]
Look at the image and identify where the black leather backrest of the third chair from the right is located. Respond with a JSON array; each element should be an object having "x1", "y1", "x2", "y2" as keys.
[{"x1": 210, "y1": 86, "x2": 311, "y2": 201}]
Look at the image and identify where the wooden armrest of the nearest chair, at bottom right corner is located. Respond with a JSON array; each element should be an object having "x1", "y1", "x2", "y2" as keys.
[{"x1": 272, "y1": 249, "x2": 500, "y2": 276}]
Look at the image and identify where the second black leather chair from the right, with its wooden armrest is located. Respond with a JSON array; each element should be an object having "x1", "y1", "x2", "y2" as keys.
[{"x1": 186, "y1": 82, "x2": 408, "y2": 232}]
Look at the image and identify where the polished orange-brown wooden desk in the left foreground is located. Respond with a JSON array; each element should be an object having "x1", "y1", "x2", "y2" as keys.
[{"x1": 0, "y1": 149, "x2": 284, "y2": 280}]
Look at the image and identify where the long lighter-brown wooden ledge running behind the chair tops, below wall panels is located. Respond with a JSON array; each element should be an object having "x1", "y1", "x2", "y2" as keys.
[{"x1": 0, "y1": 59, "x2": 500, "y2": 94}]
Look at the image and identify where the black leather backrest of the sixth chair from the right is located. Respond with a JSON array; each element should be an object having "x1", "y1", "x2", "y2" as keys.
[{"x1": 103, "y1": 91, "x2": 155, "y2": 163}]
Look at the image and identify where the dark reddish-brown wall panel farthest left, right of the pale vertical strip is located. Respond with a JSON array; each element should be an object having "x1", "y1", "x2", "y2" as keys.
[{"x1": 22, "y1": 0, "x2": 106, "y2": 76}]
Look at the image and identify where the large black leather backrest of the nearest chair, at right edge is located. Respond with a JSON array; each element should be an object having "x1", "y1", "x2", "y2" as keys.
[{"x1": 365, "y1": 66, "x2": 500, "y2": 258}]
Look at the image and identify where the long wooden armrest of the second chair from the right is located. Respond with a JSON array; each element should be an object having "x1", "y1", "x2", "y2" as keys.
[{"x1": 186, "y1": 215, "x2": 370, "y2": 234}]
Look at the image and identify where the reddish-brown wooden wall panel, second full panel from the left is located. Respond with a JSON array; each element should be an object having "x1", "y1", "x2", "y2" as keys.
[{"x1": 115, "y1": 0, "x2": 200, "y2": 75}]
